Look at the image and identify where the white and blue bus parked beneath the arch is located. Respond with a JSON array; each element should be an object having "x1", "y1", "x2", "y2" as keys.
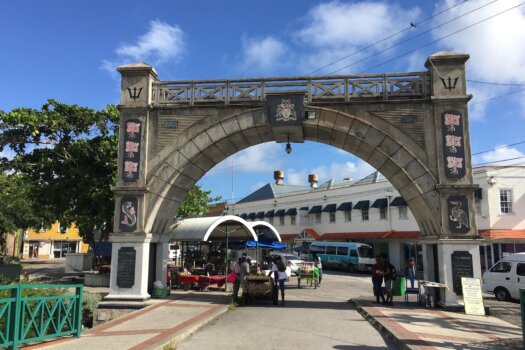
[{"x1": 309, "y1": 242, "x2": 376, "y2": 272}]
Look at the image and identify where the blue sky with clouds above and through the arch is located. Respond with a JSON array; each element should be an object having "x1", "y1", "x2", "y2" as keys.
[{"x1": 0, "y1": 0, "x2": 525, "y2": 200}]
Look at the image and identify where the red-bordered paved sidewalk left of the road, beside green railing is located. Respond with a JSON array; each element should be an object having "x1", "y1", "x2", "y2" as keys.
[{"x1": 23, "y1": 292, "x2": 230, "y2": 350}]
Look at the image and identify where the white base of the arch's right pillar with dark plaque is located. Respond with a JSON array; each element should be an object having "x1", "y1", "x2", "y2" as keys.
[{"x1": 422, "y1": 239, "x2": 481, "y2": 310}]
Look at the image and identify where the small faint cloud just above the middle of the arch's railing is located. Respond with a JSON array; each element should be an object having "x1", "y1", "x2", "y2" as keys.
[{"x1": 241, "y1": 36, "x2": 288, "y2": 72}]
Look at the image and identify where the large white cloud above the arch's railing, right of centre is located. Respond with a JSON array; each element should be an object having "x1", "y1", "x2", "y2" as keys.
[{"x1": 295, "y1": 1, "x2": 421, "y2": 72}]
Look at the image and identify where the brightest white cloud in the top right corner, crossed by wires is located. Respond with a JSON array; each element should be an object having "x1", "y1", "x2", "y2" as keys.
[{"x1": 432, "y1": 0, "x2": 525, "y2": 83}]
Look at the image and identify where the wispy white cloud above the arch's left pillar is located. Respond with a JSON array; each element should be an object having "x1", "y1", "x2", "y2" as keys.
[{"x1": 100, "y1": 20, "x2": 186, "y2": 74}]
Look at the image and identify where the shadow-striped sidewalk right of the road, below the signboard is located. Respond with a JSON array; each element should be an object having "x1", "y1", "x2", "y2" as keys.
[{"x1": 349, "y1": 299, "x2": 522, "y2": 350}]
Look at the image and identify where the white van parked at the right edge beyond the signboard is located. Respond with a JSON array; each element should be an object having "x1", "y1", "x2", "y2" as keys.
[{"x1": 482, "y1": 253, "x2": 525, "y2": 301}]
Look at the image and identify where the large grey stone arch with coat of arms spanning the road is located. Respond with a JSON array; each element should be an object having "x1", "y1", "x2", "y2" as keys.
[{"x1": 108, "y1": 52, "x2": 481, "y2": 303}]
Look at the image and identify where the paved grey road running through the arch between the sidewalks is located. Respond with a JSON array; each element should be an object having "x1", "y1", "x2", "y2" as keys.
[{"x1": 177, "y1": 272, "x2": 397, "y2": 350}]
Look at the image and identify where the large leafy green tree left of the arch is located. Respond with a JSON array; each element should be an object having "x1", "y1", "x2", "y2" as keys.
[{"x1": 0, "y1": 100, "x2": 119, "y2": 241}]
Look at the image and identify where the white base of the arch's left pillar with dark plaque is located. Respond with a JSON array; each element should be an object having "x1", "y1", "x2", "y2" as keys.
[{"x1": 104, "y1": 241, "x2": 151, "y2": 302}]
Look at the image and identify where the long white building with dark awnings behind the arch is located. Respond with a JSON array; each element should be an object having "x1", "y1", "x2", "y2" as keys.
[{"x1": 227, "y1": 166, "x2": 525, "y2": 271}]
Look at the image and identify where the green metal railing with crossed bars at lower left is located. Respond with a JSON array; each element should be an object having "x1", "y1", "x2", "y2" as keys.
[{"x1": 0, "y1": 284, "x2": 83, "y2": 349}]
